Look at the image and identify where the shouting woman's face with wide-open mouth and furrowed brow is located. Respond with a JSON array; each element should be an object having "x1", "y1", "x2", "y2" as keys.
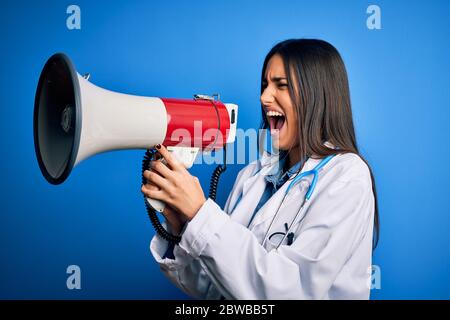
[{"x1": 261, "y1": 54, "x2": 298, "y2": 150}]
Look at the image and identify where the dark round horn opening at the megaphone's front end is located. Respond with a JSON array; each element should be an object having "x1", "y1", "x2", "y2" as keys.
[{"x1": 34, "y1": 53, "x2": 81, "y2": 184}]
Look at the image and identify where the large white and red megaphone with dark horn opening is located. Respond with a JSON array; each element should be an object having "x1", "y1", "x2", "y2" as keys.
[{"x1": 33, "y1": 53, "x2": 238, "y2": 242}]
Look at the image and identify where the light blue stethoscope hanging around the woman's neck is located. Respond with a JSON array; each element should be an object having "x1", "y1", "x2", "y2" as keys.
[{"x1": 262, "y1": 154, "x2": 335, "y2": 249}]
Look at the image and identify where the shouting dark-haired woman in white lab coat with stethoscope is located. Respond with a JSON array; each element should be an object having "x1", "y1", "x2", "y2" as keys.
[{"x1": 142, "y1": 39, "x2": 378, "y2": 299}]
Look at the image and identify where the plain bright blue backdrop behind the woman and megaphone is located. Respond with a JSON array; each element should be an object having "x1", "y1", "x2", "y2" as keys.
[{"x1": 0, "y1": 0, "x2": 450, "y2": 299}]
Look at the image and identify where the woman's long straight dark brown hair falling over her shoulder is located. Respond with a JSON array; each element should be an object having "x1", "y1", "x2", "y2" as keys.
[{"x1": 261, "y1": 39, "x2": 380, "y2": 249}]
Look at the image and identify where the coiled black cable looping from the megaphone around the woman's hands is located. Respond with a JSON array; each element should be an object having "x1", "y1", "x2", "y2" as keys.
[{"x1": 141, "y1": 145, "x2": 227, "y2": 244}]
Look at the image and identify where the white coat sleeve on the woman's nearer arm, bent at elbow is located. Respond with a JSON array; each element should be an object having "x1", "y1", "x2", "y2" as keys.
[{"x1": 180, "y1": 158, "x2": 373, "y2": 299}]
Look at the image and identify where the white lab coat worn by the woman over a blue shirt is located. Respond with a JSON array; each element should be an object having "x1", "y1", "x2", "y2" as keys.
[{"x1": 150, "y1": 153, "x2": 374, "y2": 299}]
